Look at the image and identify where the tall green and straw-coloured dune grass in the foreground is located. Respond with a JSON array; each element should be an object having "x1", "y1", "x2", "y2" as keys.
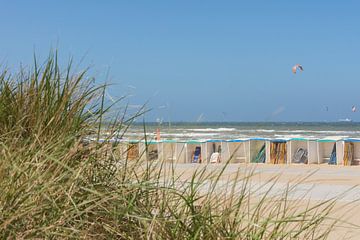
[{"x1": 0, "y1": 54, "x2": 344, "y2": 239}]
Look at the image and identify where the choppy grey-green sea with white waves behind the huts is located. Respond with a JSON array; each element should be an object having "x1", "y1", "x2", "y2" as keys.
[{"x1": 122, "y1": 122, "x2": 360, "y2": 140}]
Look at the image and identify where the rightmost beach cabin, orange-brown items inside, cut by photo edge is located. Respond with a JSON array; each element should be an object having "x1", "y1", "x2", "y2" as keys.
[{"x1": 343, "y1": 138, "x2": 360, "y2": 166}]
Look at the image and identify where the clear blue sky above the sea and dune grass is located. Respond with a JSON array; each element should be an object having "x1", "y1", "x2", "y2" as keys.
[{"x1": 0, "y1": 0, "x2": 360, "y2": 122}]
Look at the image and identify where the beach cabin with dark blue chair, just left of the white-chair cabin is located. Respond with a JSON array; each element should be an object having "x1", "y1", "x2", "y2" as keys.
[{"x1": 185, "y1": 140, "x2": 207, "y2": 163}]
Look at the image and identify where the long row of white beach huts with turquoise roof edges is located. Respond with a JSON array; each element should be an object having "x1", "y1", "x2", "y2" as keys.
[{"x1": 95, "y1": 138, "x2": 360, "y2": 166}]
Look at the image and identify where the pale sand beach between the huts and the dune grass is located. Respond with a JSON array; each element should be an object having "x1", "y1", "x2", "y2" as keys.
[{"x1": 160, "y1": 164, "x2": 360, "y2": 239}]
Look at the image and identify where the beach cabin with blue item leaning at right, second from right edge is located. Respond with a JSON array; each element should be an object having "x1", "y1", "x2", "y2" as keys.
[{"x1": 316, "y1": 138, "x2": 341, "y2": 165}]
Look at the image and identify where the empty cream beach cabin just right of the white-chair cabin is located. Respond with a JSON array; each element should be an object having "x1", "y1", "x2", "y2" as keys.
[{"x1": 223, "y1": 139, "x2": 249, "y2": 163}]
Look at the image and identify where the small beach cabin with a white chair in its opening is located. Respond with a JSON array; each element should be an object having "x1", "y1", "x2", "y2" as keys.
[{"x1": 204, "y1": 139, "x2": 227, "y2": 163}]
